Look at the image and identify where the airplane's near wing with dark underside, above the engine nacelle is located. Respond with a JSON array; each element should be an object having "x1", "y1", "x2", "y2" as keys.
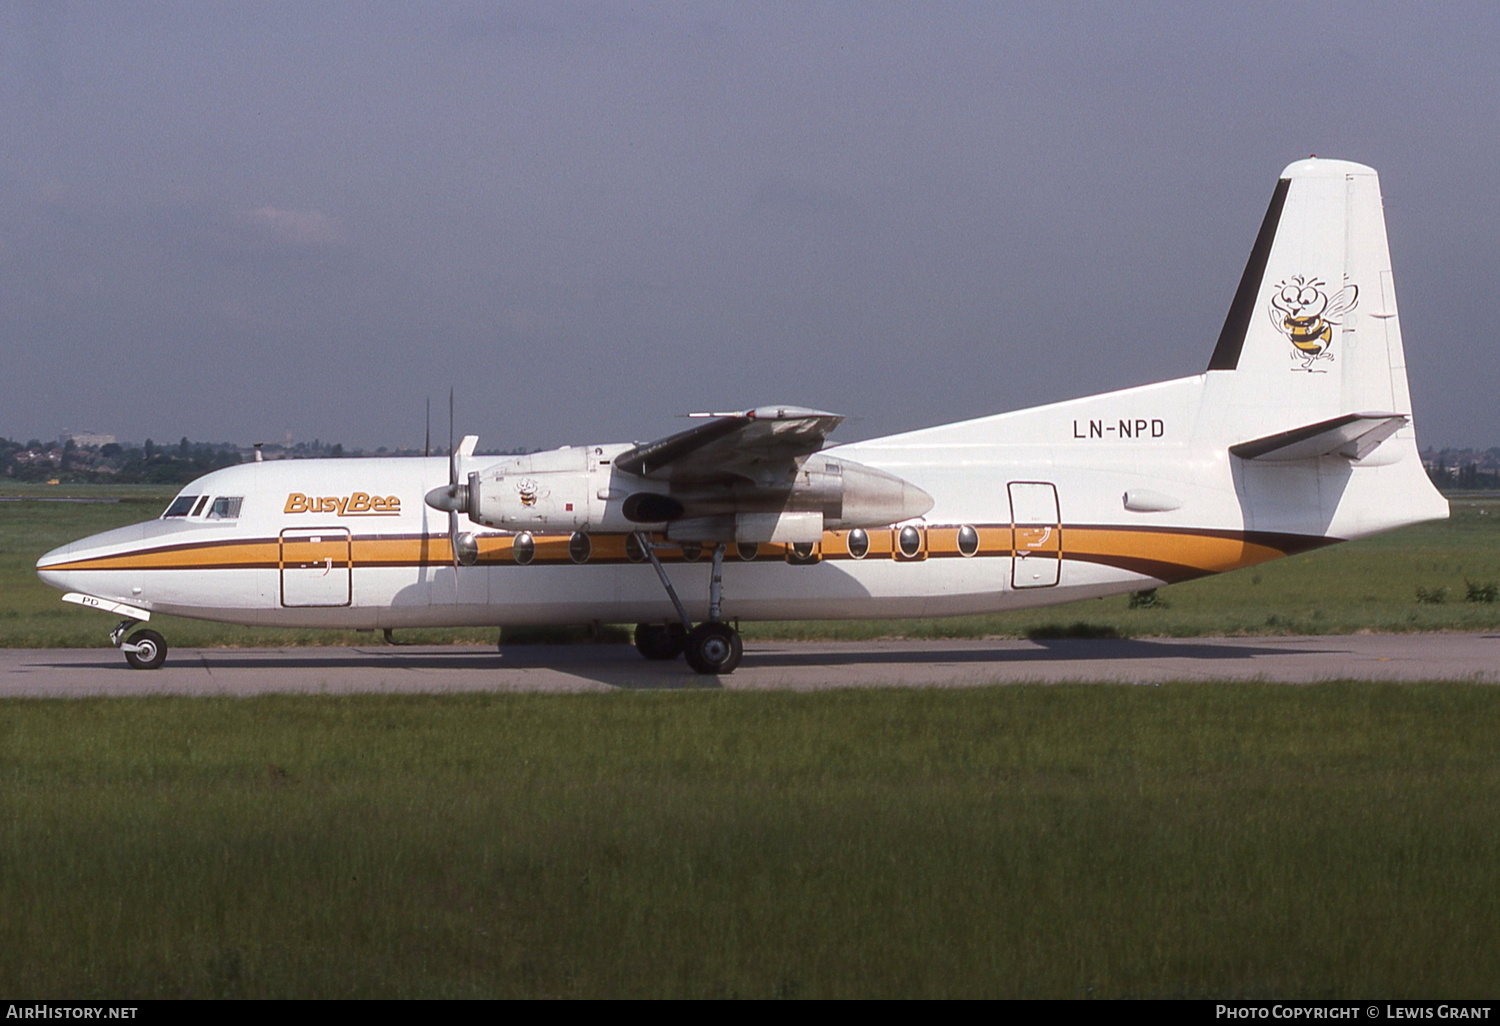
[{"x1": 615, "y1": 407, "x2": 843, "y2": 483}]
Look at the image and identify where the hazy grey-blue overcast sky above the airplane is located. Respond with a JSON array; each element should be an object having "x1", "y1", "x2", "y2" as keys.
[{"x1": 0, "y1": 0, "x2": 1500, "y2": 449}]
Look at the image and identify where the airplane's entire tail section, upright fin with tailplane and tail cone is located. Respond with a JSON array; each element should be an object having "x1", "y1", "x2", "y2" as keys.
[{"x1": 1200, "y1": 159, "x2": 1448, "y2": 537}]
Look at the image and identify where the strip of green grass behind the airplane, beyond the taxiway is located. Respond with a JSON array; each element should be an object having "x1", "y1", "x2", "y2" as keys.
[{"x1": 0, "y1": 485, "x2": 1500, "y2": 648}]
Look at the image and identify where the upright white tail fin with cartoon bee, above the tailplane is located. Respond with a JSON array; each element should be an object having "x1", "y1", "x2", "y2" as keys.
[{"x1": 1209, "y1": 159, "x2": 1412, "y2": 429}]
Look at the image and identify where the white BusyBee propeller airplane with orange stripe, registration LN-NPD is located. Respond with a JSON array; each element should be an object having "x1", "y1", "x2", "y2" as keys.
[{"x1": 36, "y1": 158, "x2": 1448, "y2": 675}]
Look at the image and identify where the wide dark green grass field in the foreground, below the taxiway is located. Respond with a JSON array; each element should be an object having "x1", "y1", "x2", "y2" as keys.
[{"x1": 0, "y1": 684, "x2": 1500, "y2": 998}]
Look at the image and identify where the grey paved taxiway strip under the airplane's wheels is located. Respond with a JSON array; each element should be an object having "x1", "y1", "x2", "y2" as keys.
[{"x1": 0, "y1": 633, "x2": 1500, "y2": 698}]
